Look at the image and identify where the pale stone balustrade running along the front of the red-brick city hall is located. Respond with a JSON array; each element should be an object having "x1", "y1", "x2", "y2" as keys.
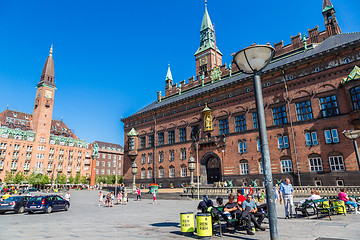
[{"x1": 183, "y1": 186, "x2": 360, "y2": 197}]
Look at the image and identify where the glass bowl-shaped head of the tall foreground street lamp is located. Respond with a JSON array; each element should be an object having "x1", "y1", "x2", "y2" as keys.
[{"x1": 234, "y1": 44, "x2": 275, "y2": 74}]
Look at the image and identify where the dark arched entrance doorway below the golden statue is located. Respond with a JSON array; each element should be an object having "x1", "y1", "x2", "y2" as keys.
[{"x1": 201, "y1": 153, "x2": 221, "y2": 184}]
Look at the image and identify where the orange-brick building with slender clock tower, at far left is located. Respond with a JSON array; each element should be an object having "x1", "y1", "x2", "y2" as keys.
[{"x1": 0, "y1": 48, "x2": 92, "y2": 181}]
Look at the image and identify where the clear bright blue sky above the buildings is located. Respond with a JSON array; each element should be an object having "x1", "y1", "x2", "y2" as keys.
[{"x1": 0, "y1": 0, "x2": 360, "y2": 144}]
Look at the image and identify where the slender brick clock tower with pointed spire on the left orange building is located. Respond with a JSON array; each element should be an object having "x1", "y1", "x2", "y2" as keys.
[{"x1": 32, "y1": 46, "x2": 56, "y2": 142}]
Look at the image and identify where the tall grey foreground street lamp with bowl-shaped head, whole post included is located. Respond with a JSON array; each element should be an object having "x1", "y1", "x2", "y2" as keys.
[{"x1": 234, "y1": 45, "x2": 279, "y2": 240}]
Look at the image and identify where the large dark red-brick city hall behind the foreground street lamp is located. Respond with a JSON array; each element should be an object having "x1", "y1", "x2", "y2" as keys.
[{"x1": 122, "y1": 0, "x2": 360, "y2": 187}]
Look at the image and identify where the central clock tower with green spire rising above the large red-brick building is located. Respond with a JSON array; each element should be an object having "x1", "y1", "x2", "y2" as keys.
[{"x1": 194, "y1": 1, "x2": 222, "y2": 78}]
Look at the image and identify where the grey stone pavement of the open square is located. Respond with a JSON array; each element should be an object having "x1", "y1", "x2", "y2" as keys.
[{"x1": 0, "y1": 191, "x2": 360, "y2": 239}]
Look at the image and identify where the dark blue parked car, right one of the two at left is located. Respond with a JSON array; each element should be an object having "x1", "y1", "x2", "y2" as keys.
[{"x1": 25, "y1": 195, "x2": 70, "y2": 213}]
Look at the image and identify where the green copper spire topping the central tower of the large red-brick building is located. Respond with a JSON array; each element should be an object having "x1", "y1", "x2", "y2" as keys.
[{"x1": 195, "y1": 1, "x2": 221, "y2": 55}]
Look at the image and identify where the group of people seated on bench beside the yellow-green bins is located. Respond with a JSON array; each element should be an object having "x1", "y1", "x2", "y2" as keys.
[{"x1": 198, "y1": 189, "x2": 265, "y2": 235}]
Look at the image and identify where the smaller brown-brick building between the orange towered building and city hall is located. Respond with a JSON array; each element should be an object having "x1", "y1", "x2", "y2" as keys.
[{"x1": 95, "y1": 141, "x2": 124, "y2": 176}]
